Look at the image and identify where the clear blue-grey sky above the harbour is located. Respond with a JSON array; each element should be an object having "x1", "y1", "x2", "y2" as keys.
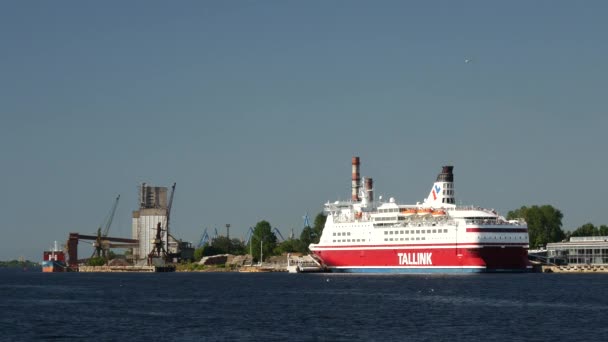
[{"x1": 0, "y1": 0, "x2": 608, "y2": 261}]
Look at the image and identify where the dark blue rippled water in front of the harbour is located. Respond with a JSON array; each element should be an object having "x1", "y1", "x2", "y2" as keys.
[{"x1": 0, "y1": 270, "x2": 608, "y2": 342}]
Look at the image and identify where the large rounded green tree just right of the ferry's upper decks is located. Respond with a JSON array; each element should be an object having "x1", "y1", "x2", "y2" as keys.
[{"x1": 507, "y1": 205, "x2": 566, "y2": 248}]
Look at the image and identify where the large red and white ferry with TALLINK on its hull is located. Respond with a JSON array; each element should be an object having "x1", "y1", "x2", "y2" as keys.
[{"x1": 309, "y1": 157, "x2": 532, "y2": 273}]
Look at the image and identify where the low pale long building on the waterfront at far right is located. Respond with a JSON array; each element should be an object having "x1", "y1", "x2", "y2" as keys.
[{"x1": 547, "y1": 236, "x2": 608, "y2": 265}]
